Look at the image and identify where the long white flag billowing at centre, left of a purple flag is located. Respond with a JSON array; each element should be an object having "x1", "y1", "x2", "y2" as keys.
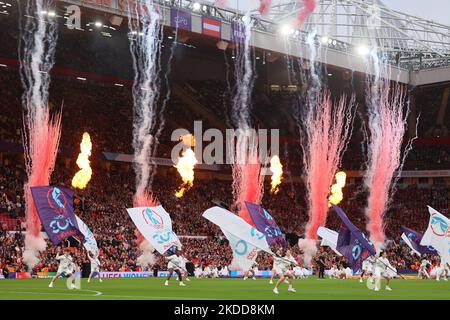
[{"x1": 203, "y1": 207, "x2": 273, "y2": 254}]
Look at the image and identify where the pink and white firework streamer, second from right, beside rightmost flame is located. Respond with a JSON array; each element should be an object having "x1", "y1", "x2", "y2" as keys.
[{"x1": 295, "y1": 21, "x2": 355, "y2": 265}]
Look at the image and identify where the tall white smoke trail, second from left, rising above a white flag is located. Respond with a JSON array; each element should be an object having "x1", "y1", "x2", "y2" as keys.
[{"x1": 128, "y1": 0, "x2": 162, "y2": 195}]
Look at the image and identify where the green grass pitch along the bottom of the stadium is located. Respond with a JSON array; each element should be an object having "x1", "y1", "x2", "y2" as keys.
[{"x1": 0, "y1": 277, "x2": 450, "y2": 300}]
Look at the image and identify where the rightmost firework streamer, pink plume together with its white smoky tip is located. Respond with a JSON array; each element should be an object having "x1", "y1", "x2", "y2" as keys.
[{"x1": 364, "y1": 44, "x2": 415, "y2": 245}]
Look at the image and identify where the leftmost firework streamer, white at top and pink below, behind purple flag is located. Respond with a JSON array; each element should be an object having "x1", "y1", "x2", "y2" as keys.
[{"x1": 19, "y1": 0, "x2": 61, "y2": 268}]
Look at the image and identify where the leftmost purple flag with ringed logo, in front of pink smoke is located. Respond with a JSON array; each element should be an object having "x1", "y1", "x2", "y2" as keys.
[{"x1": 31, "y1": 186, "x2": 84, "y2": 245}]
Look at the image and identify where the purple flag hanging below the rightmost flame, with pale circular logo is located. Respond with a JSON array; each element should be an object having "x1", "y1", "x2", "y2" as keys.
[{"x1": 333, "y1": 205, "x2": 376, "y2": 273}]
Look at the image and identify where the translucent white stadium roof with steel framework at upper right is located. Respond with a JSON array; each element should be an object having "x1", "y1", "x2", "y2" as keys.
[{"x1": 207, "y1": 0, "x2": 450, "y2": 70}]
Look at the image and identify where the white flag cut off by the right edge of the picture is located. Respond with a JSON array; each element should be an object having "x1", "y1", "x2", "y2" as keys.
[{"x1": 420, "y1": 206, "x2": 450, "y2": 263}]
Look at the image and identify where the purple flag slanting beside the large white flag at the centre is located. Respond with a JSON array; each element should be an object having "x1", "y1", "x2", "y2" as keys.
[{"x1": 245, "y1": 201, "x2": 287, "y2": 248}]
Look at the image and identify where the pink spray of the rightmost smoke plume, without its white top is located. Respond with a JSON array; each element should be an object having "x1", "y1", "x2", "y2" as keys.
[{"x1": 364, "y1": 80, "x2": 411, "y2": 248}]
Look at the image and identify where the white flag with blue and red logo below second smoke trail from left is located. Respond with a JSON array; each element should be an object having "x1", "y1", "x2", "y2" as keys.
[{"x1": 127, "y1": 206, "x2": 181, "y2": 254}]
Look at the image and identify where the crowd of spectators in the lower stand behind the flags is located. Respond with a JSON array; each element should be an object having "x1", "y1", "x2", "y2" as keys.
[{"x1": 0, "y1": 159, "x2": 450, "y2": 271}]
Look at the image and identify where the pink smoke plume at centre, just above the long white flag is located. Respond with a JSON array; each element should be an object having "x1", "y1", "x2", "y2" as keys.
[{"x1": 232, "y1": 138, "x2": 264, "y2": 225}]
